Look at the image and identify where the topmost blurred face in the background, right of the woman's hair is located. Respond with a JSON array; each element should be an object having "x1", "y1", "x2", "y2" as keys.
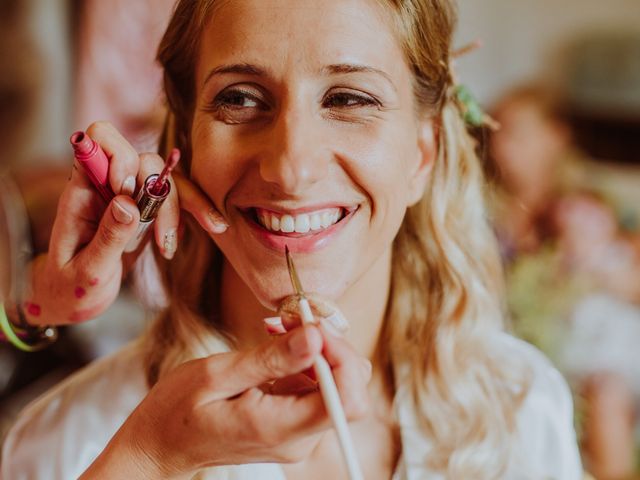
[{"x1": 490, "y1": 100, "x2": 567, "y2": 197}]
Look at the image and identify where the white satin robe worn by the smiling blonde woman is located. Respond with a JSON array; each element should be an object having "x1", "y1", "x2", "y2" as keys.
[{"x1": 0, "y1": 334, "x2": 582, "y2": 480}]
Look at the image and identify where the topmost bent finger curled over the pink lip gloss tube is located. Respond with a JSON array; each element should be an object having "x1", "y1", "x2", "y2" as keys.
[{"x1": 87, "y1": 122, "x2": 139, "y2": 195}]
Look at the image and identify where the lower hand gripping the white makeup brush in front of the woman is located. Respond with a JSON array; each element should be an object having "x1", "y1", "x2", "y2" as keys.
[{"x1": 83, "y1": 326, "x2": 371, "y2": 478}]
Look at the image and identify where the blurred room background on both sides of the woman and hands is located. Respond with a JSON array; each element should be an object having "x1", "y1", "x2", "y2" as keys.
[{"x1": 0, "y1": 0, "x2": 640, "y2": 480}]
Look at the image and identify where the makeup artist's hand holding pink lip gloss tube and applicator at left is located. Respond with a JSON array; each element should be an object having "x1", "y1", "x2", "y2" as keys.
[{"x1": 24, "y1": 122, "x2": 228, "y2": 325}]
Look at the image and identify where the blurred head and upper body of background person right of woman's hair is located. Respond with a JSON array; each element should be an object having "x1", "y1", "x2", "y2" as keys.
[{"x1": 489, "y1": 85, "x2": 583, "y2": 259}]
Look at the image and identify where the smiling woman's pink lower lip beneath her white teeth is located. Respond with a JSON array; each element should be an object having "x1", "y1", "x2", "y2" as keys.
[{"x1": 241, "y1": 207, "x2": 358, "y2": 253}]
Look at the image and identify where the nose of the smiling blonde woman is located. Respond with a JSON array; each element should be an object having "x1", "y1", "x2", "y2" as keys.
[{"x1": 260, "y1": 104, "x2": 330, "y2": 195}]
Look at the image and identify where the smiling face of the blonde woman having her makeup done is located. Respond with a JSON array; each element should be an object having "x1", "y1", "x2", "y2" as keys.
[{"x1": 191, "y1": 0, "x2": 435, "y2": 308}]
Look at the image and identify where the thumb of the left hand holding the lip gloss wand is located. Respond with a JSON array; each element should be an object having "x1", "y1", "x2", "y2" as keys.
[{"x1": 79, "y1": 195, "x2": 140, "y2": 271}]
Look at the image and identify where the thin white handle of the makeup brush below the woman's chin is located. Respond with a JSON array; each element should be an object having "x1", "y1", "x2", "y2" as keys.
[{"x1": 300, "y1": 297, "x2": 364, "y2": 480}]
